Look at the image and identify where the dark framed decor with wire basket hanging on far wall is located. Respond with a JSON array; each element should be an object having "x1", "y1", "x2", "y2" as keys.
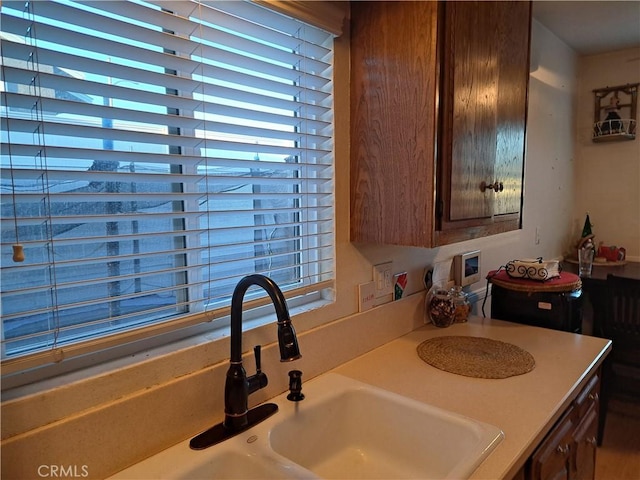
[{"x1": 592, "y1": 83, "x2": 640, "y2": 142}]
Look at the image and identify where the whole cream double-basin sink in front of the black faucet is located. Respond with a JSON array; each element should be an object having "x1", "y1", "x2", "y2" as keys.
[{"x1": 111, "y1": 374, "x2": 503, "y2": 480}]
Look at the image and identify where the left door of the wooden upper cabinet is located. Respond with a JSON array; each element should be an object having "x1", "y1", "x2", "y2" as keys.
[{"x1": 441, "y1": 2, "x2": 499, "y2": 220}]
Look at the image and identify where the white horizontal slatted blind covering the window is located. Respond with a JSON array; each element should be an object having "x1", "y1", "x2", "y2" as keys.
[{"x1": 0, "y1": 0, "x2": 334, "y2": 371}]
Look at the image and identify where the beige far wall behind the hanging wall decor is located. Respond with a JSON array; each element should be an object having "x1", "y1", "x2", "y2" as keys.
[{"x1": 573, "y1": 47, "x2": 640, "y2": 261}]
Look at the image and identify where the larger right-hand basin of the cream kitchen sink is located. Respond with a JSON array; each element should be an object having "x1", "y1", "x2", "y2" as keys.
[{"x1": 269, "y1": 374, "x2": 503, "y2": 479}]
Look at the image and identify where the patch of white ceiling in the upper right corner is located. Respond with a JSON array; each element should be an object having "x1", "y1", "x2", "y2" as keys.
[{"x1": 533, "y1": 0, "x2": 640, "y2": 55}]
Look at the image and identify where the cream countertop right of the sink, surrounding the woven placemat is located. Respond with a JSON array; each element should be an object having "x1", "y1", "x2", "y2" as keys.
[{"x1": 333, "y1": 317, "x2": 610, "y2": 479}]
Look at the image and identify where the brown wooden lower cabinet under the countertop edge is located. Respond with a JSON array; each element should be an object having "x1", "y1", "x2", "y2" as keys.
[{"x1": 524, "y1": 370, "x2": 600, "y2": 480}]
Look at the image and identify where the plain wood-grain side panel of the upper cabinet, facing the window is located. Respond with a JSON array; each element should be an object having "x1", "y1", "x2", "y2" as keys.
[{"x1": 351, "y1": 1, "x2": 439, "y2": 246}]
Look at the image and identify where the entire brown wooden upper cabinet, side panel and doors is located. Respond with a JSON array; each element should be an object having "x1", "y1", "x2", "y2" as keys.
[{"x1": 351, "y1": 1, "x2": 531, "y2": 247}]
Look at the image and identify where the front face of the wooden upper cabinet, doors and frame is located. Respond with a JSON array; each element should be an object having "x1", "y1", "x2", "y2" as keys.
[{"x1": 435, "y1": 1, "x2": 531, "y2": 244}]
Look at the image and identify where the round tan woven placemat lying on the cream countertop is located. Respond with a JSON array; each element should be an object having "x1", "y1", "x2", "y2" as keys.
[{"x1": 417, "y1": 336, "x2": 536, "y2": 378}]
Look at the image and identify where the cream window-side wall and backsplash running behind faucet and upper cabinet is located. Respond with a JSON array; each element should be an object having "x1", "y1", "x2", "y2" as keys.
[{"x1": 2, "y1": 17, "x2": 577, "y2": 478}]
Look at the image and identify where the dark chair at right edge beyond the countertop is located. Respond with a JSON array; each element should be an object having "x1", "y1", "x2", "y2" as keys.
[{"x1": 599, "y1": 274, "x2": 640, "y2": 441}]
